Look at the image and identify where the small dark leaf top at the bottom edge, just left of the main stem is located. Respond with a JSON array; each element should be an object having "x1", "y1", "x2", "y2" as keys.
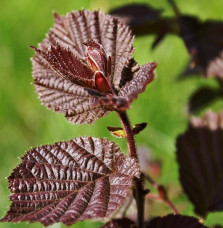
[{"x1": 101, "y1": 218, "x2": 138, "y2": 228}]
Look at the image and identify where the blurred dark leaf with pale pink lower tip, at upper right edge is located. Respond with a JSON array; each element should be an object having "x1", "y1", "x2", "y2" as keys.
[{"x1": 179, "y1": 16, "x2": 223, "y2": 78}]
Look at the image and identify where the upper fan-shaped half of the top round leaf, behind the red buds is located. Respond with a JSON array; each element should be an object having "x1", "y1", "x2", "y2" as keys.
[{"x1": 34, "y1": 10, "x2": 138, "y2": 89}]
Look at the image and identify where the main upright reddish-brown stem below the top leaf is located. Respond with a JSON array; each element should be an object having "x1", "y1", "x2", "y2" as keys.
[{"x1": 118, "y1": 112, "x2": 145, "y2": 228}]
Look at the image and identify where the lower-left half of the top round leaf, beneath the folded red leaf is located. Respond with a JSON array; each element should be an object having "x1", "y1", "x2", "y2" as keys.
[{"x1": 35, "y1": 69, "x2": 109, "y2": 124}]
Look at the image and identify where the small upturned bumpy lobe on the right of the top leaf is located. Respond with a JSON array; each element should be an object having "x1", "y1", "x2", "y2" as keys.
[{"x1": 119, "y1": 62, "x2": 157, "y2": 102}]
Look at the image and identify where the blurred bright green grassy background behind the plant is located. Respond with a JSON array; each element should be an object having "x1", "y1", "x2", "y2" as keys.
[{"x1": 0, "y1": 0, "x2": 223, "y2": 228}]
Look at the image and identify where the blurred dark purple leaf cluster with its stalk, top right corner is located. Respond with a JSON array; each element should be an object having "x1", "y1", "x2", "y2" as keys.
[{"x1": 110, "y1": 1, "x2": 223, "y2": 78}]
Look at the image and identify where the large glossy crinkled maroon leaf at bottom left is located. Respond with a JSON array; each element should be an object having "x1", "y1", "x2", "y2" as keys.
[{"x1": 1, "y1": 137, "x2": 140, "y2": 226}]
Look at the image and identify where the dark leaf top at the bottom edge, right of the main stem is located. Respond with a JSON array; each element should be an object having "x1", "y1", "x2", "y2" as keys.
[{"x1": 147, "y1": 214, "x2": 208, "y2": 228}]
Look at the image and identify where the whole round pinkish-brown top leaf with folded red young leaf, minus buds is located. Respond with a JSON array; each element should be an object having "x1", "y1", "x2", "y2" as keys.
[{"x1": 32, "y1": 10, "x2": 155, "y2": 124}]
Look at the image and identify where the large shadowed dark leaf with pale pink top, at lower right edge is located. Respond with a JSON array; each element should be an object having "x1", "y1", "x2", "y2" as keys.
[{"x1": 177, "y1": 112, "x2": 223, "y2": 217}]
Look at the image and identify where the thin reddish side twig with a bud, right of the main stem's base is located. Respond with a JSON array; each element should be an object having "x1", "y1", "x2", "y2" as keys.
[{"x1": 145, "y1": 175, "x2": 180, "y2": 214}]
